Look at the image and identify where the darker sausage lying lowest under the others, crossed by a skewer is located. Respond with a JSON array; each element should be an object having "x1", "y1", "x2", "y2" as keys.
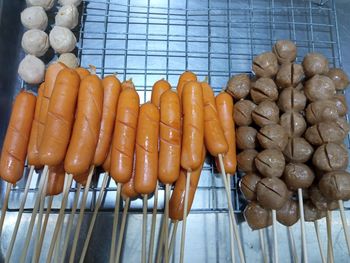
[{"x1": 169, "y1": 146, "x2": 206, "y2": 220}]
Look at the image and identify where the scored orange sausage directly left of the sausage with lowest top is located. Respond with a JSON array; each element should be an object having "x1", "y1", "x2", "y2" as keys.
[{"x1": 110, "y1": 88, "x2": 140, "y2": 184}]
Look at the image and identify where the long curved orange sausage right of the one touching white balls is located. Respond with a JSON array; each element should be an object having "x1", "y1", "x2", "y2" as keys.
[{"x1": 64, "y1": 74, "x2": 103, "y2": 174}]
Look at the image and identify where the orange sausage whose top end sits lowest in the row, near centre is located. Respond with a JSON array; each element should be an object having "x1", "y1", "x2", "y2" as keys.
[{"x1": 135, "y1": 103, "x2": 159, "y2": 195}]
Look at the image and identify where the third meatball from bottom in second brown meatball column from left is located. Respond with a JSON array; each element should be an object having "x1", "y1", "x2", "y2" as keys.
[{"x1": 257, "y1": 124, "x2": 288, "y2": 151}]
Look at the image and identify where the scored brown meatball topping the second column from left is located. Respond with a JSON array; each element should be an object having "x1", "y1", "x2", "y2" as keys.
[{"x1": 253, "y1": 52, "x2": 278, "y2": 78}]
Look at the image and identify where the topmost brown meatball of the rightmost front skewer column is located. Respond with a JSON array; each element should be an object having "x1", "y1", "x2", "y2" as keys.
[{"x1": 302, "y1": 53, "x2": 329, "y2": 77}]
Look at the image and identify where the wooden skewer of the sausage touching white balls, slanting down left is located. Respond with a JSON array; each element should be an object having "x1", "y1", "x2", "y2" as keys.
[{"x1": 20, "y1": 165, "x2": 49, "y2": 263}]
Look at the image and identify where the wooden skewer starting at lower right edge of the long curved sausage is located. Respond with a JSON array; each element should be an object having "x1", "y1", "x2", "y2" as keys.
[{"x1": 69, "y1": 165, "x2": 95, "y2": 263}]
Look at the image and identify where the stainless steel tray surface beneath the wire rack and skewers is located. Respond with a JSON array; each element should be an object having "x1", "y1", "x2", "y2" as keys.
[{"x1": 0, "y1": 0, "x2": 350, "y2": 262}]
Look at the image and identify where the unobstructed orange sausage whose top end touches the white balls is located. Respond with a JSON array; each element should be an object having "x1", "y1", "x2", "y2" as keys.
[{"x1": 39, "y1": 68, "x2": 80, "y2": 166}]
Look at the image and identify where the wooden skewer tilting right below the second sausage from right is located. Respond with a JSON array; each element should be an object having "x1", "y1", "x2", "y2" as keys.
[{"x1": 218, "y1": 154, "x2": 245, "y2": 263}]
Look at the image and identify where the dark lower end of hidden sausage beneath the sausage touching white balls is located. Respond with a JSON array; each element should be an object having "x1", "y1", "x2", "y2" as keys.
[{"x1": 46, "y1": 163, "x2": 66, "y2": 196}]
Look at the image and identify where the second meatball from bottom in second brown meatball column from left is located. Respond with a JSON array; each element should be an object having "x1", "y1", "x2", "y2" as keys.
[{"x1": 255, "y1": 149, "x2": 285, "y2": 177}]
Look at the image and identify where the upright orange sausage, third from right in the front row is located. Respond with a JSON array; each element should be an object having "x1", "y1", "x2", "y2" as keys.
[{"x1": 181, "y1": 81, "x2": 204, "y2": 171}]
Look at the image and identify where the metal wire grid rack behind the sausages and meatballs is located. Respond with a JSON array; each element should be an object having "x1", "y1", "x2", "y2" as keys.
[{"x1": 9, "y1": 0, "x2": 349, "y2": 216}]
